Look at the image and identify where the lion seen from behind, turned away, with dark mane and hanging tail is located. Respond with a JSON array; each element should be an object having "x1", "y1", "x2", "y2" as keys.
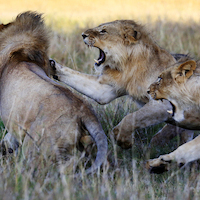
[{"x1": 0, "y1": 11, "x2": 107, "y2": 173}]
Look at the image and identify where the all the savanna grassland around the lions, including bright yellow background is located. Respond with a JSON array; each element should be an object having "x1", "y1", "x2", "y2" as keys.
[{"x1": 0, "y1": 0, "x2": 200, "y2": 200}]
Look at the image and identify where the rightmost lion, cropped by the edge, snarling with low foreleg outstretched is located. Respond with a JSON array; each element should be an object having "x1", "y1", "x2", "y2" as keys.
[{"x1": 147, "y1": 60, "x2": 200, "y2": 173}]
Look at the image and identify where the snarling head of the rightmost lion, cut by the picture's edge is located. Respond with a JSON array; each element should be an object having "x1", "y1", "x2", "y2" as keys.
[{"x1": 148, "y1": 60, "x2": 200, "y2": 124}]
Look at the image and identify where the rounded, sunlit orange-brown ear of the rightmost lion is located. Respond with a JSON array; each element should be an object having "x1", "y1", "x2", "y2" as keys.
[{"x1": 174, "y1": 60, "x2": 196, "y2": 83}]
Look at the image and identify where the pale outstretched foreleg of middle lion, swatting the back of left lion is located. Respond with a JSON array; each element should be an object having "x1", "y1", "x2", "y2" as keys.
[{"x1": 50, "y1": 60, "x2": 121, "y2": 104}]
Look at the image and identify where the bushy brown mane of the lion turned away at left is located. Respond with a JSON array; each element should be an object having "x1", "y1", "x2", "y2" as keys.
[{"x1": 0, "y1": 11, "x2": 49, "y2": 74}]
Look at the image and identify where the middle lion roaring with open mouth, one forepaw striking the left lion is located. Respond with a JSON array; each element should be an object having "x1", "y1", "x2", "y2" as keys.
[{"x1": 50, "y1": 20, "x2": 193, "y2": 148}]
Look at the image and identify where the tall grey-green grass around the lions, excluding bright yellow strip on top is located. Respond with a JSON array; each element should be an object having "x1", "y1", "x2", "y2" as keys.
[{"x1": 0, "y1": 18, "x2": 200, "y2": 200}]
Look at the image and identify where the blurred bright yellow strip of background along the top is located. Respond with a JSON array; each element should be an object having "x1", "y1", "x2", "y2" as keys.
[{"x1": 0, "y1": 0, "x2": 200, "y2": 29}]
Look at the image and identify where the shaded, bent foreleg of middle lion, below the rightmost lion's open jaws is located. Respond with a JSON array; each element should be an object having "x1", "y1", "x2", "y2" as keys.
[{"x1": 113, "y1": 100, "x2": 172, "y2": 148}]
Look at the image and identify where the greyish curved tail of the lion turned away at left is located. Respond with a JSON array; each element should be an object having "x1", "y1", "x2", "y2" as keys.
[{"x1": 82, "y1": 111, "x2": 108, "y2": 174}]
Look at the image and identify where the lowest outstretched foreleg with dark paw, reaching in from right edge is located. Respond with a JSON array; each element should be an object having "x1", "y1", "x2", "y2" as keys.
[{"x1": 146, "y1": 135, "x2": 200, "y2": 173}]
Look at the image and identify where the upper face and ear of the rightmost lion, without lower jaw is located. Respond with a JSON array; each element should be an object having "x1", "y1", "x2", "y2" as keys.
[{"x1": 148, "y1": 60, "x2": 196, "y2": 101}]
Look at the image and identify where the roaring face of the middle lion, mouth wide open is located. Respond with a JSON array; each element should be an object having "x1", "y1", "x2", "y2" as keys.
[{"x1": 82, "y1": 20, "x2": 142, "y2": 69}]
